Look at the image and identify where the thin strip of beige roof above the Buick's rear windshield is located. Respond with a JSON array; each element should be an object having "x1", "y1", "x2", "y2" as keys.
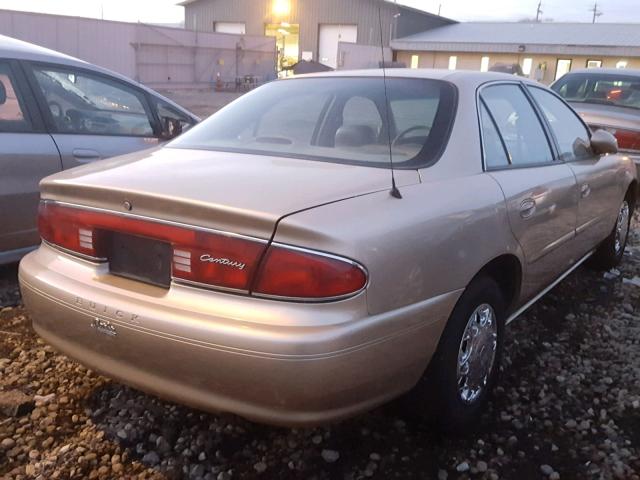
[{"x1": 294, "y1": 68, "x2": 540, "y2": 89}]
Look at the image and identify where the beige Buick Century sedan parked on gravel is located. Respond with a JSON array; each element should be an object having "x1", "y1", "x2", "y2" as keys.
[{"x1": 20, "y1": 70, "x2": 637, "y2": 428}]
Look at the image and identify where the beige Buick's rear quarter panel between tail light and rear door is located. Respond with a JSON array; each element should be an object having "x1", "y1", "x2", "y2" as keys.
[{"x1": 275, "y1": 173, "x2": 522, "y2": 315}]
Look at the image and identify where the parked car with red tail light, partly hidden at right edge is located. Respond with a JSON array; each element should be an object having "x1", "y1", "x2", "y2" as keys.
[{"x1": 551, "y1": 68, "x2": 640, "y2": 176}]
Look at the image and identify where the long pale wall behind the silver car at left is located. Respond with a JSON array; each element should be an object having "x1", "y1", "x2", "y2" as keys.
[{"x1": 0, "y1": 10, "x2": 275, "y2": 87}]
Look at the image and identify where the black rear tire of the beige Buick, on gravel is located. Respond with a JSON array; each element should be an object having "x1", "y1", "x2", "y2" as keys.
[{"x1": 405, "y1": 276, "x2": 506, "y2": 433}]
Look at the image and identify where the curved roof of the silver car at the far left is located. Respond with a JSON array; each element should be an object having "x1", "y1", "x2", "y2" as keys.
[{"x1": 0, "y1": 35, "x2": 200, "y2": 120}]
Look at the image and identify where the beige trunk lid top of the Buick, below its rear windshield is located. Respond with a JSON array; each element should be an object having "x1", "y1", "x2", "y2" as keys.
[{"x1": 41, "y1": 148, "x2": 420, "y2": 238}]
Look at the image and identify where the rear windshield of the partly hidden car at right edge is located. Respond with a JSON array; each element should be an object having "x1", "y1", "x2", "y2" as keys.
[{"x1": 551, "y1": 73, "x2": 640, "y2": 109}]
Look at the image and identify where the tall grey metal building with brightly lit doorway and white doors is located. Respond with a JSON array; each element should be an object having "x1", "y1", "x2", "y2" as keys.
[{"x1": 181, "y1": 0, "x2": 454, "y2": 68}]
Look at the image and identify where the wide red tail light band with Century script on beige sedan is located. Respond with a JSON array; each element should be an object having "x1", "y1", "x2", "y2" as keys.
[{"x1": 38, "y1": 202, "x2": 367, "y2": 301}]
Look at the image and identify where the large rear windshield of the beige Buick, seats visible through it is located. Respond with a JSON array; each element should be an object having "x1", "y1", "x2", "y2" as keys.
[{"x1": 169, "y1": 77, "x2": 456, "y2": 168}]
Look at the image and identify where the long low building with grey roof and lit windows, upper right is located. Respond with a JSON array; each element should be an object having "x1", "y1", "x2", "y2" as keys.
[{"x1": 391, "y1": 22, "x2": 640, "y2": 84}]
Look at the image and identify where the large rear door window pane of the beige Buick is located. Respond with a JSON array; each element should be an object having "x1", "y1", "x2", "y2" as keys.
[{"x1": 481, "y1": 84, "x2": 553, "y2": 166}]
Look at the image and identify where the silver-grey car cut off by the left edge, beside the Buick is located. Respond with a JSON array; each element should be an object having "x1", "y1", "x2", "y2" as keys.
[{"x1": 0, "y1": 36, "x2": 199, "y2": 265}]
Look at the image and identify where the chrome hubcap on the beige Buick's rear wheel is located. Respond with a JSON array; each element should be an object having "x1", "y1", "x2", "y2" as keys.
[{"x1": 458, "y1": 303, "x2": 498, "y2": 404}]
